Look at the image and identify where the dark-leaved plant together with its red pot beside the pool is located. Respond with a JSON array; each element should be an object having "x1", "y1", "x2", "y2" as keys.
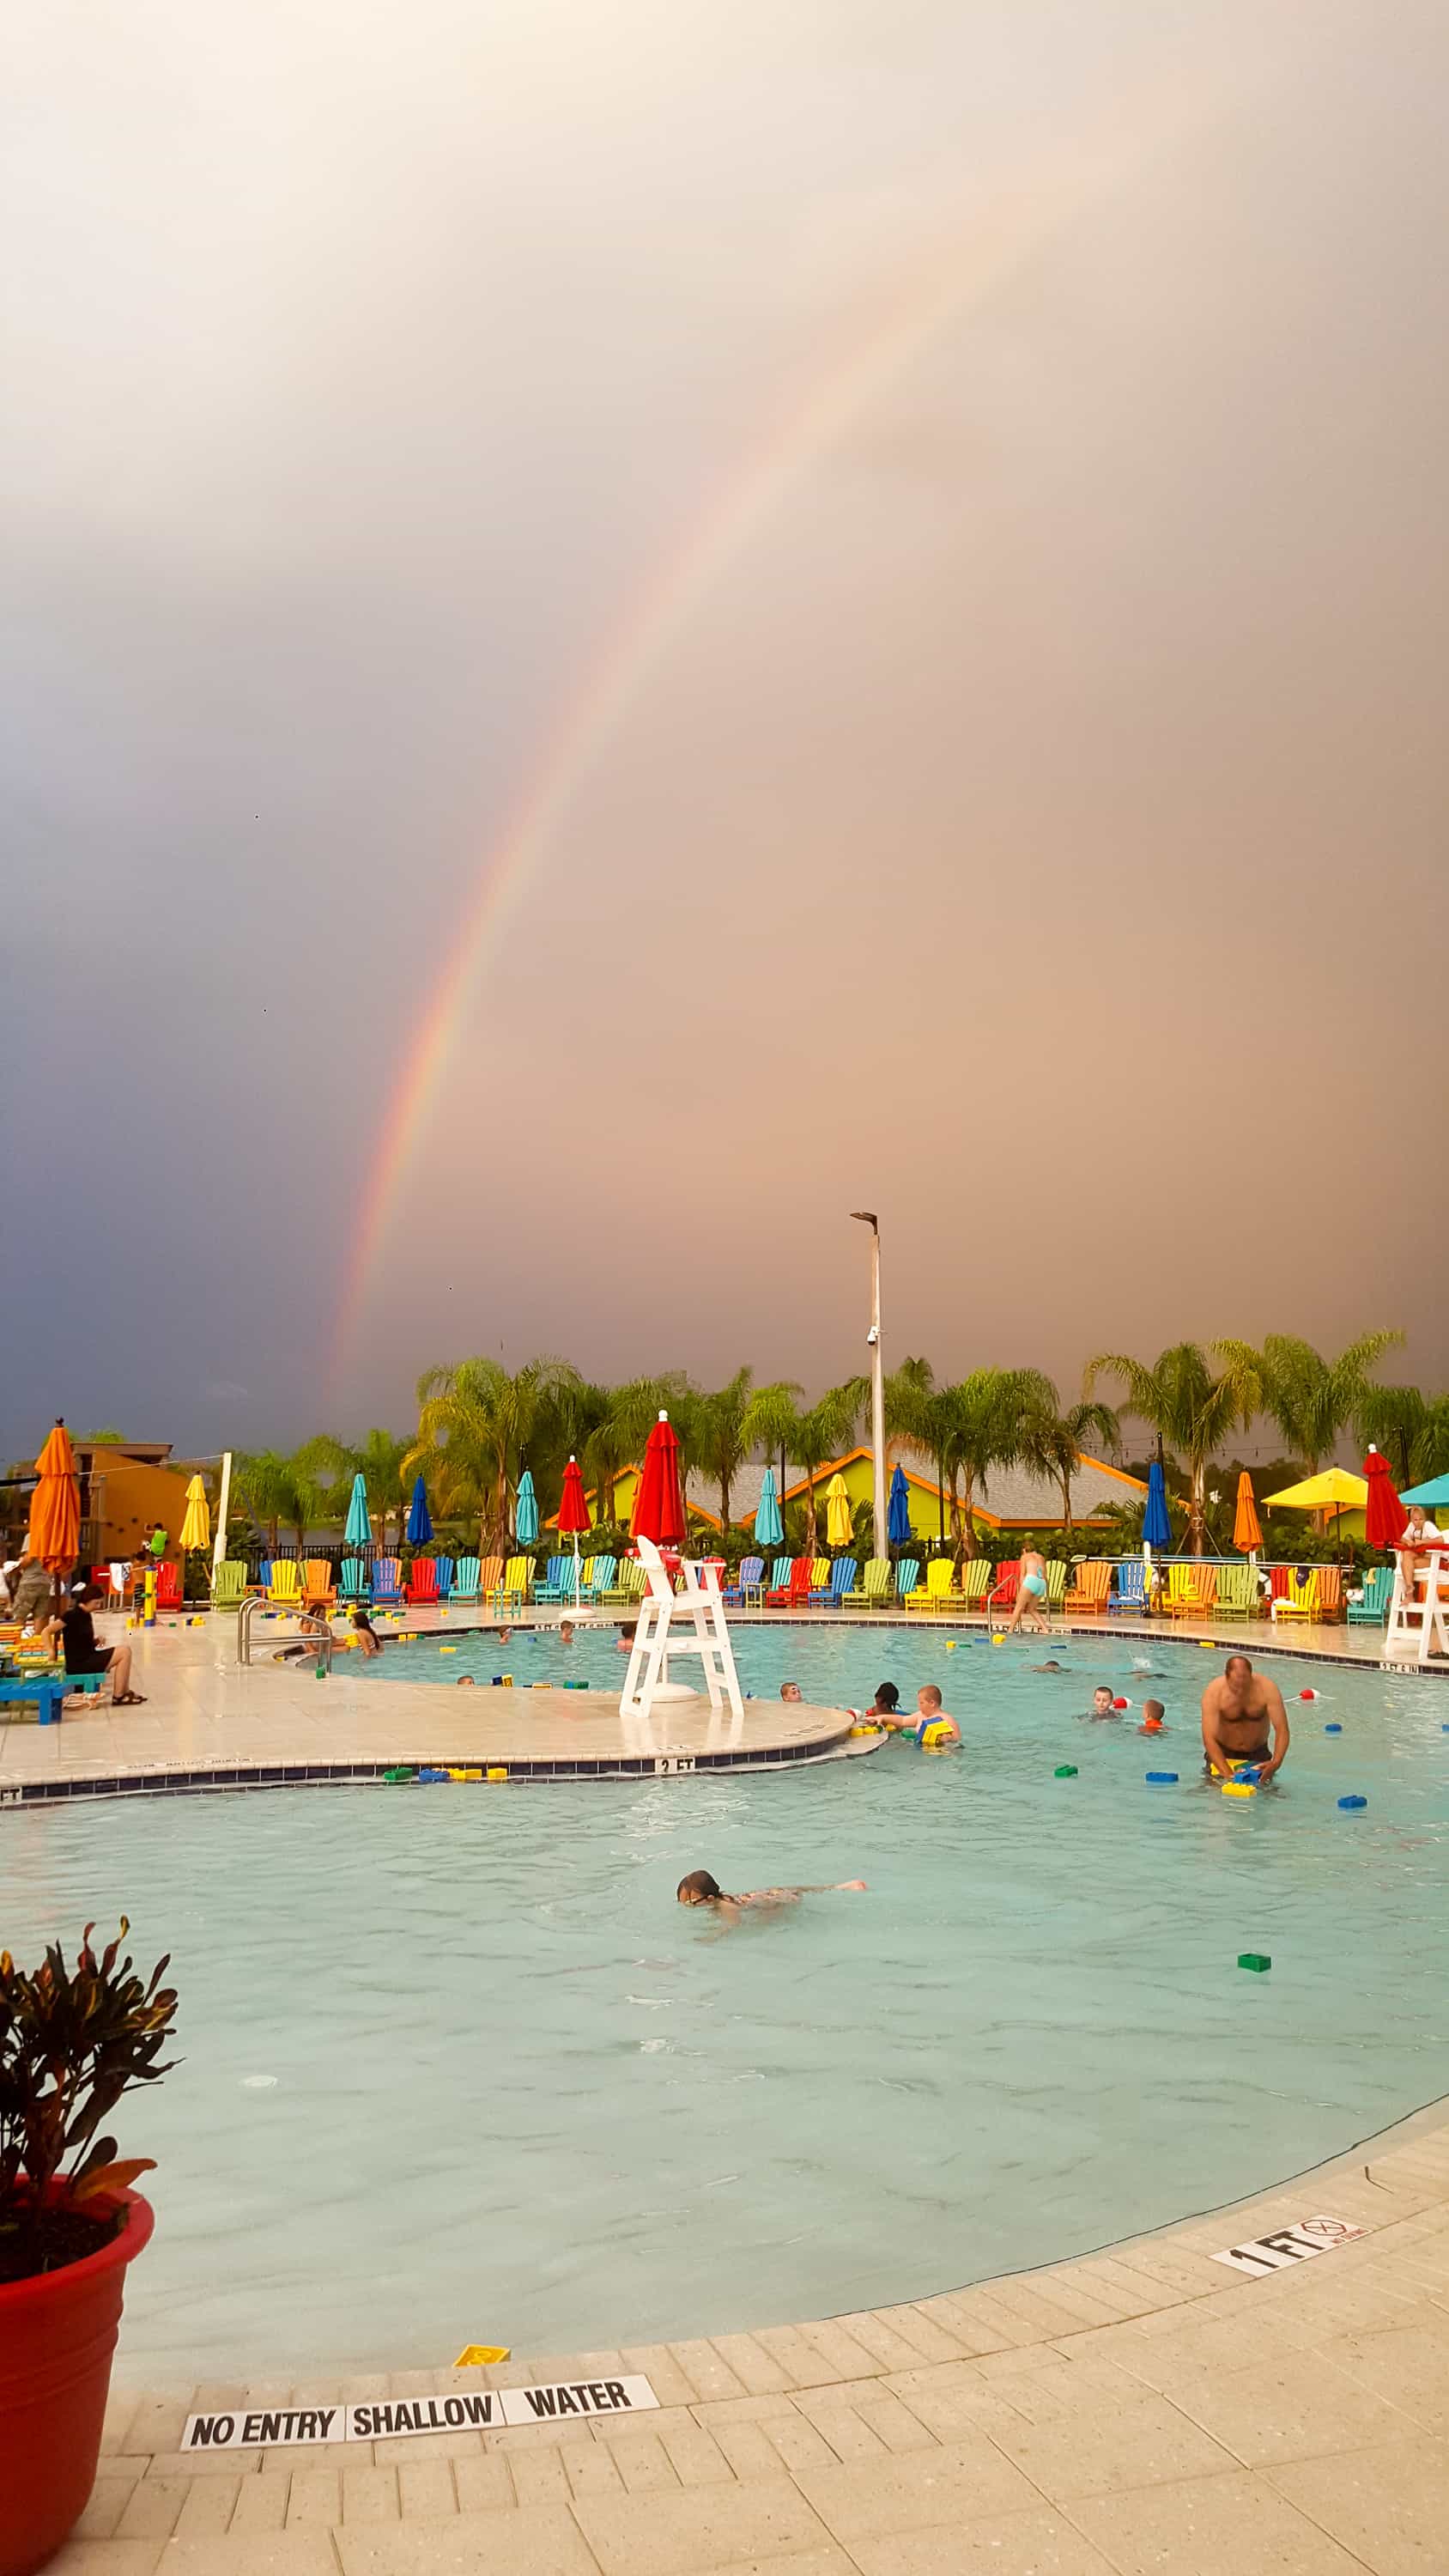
[{"x1": 0, "y1": 1917, "x2": 175, "y2": 2576}]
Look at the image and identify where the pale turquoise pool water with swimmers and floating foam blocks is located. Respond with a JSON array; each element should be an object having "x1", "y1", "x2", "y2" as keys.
[{"x1": 0, "y1": 1628, "x2": 1449, "y2": 2380}]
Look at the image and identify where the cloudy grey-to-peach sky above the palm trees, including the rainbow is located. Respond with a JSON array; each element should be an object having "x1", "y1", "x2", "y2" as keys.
[{"x1": 0, "y1": 0, "x2": 1449, "y2": 1455}]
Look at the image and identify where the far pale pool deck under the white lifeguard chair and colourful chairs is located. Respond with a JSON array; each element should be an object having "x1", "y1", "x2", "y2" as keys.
[{"x1": 0, "y1": 1610, "x2": 1449, "y2": 1803}]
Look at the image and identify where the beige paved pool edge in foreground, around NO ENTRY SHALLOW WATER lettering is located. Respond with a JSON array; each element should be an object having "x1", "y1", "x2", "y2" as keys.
[{"x1": 70, "y1": 2105, "x2": 1449, "y2": 2576}]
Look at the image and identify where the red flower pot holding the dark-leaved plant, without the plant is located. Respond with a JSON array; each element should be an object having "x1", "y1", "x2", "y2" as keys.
[{"x1": 0, "y1": 2184, "x2": 155, "y2": 2576}]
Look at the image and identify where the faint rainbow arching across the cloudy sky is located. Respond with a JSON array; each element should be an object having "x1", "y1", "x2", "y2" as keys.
[{"x1": 332, "y1": 67, "x2": 1220, "y2": 1378}]
